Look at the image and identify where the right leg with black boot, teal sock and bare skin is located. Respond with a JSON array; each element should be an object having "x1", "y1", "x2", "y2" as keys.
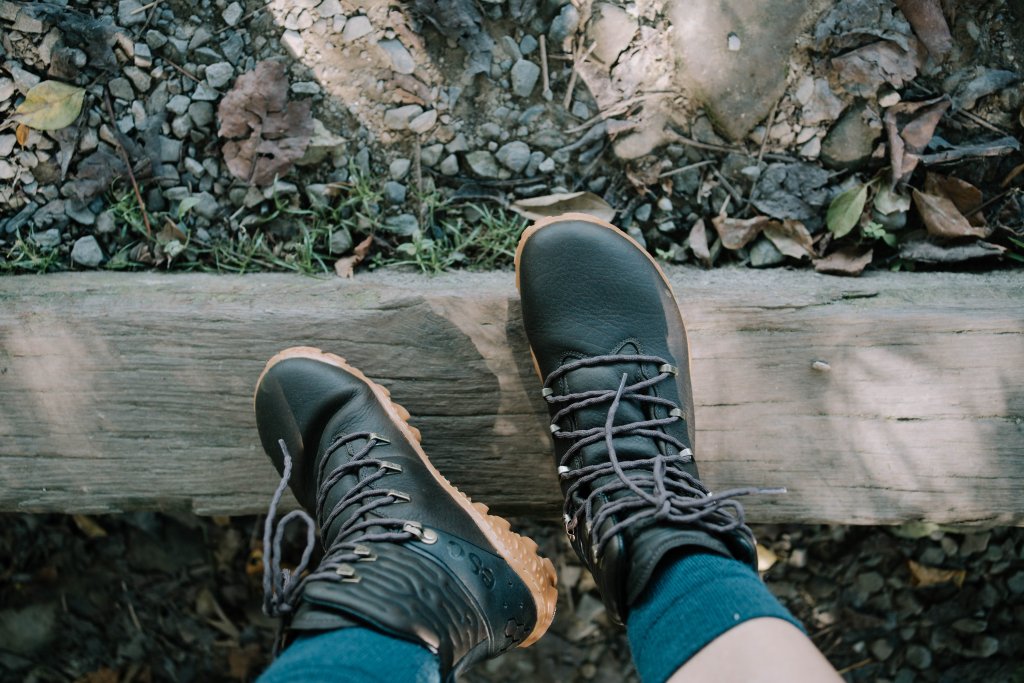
[{"x1": 516, "y1": 214, "x2": 837, "y2": 683}]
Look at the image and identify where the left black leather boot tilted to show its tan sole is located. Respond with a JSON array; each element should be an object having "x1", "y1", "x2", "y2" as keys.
[{"x1": 255, "y1": 347, "x2": 556, "y2": 678}]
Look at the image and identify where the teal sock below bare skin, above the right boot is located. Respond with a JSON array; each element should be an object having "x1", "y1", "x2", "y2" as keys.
[{"x1": 626, "y1": 553, "x2": 804, "y2": 683}]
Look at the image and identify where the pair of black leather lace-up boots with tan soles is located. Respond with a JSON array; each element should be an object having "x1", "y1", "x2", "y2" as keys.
[{"x1": 255, "y1": 215, "x2": 770, "y2": 677}]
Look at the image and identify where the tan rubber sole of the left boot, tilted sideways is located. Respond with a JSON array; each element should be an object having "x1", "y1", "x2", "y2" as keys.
[{"x1": 256, "y1": 346, "x2": 558, "y2": 647}]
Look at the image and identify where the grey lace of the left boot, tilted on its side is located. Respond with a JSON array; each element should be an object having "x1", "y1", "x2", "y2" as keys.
[{"x1": 263, "y1": 432, "x2": 432, "y2": 616}]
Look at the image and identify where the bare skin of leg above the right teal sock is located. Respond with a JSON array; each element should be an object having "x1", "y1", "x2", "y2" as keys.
[{"x1": 669, "y1": 617, "x2": 843, "y2": 683}]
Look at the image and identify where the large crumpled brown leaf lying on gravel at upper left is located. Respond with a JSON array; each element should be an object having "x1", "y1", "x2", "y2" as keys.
[{"x1": 217, "y1": 60, "x2": 313, "y2": 186}]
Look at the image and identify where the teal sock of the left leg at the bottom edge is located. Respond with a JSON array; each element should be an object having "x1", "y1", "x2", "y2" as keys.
[{"x1": 257, "y1": 628, "x2": 440, "y2": 683}]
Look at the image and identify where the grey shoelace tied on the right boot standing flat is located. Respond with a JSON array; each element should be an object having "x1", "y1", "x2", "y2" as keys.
[{"x1": 544, "y1": 354, "x2": 785, "y2": 561}]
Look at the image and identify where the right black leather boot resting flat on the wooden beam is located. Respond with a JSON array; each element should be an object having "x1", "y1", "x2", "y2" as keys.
[{"x1": 516, "y1": 214, "x2": 770, "y2": 622}]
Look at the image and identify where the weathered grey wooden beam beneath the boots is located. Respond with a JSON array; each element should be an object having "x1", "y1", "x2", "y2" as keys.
[{"x1": 0, "y1": 268, "x2": 1024, "y2": 524}]
